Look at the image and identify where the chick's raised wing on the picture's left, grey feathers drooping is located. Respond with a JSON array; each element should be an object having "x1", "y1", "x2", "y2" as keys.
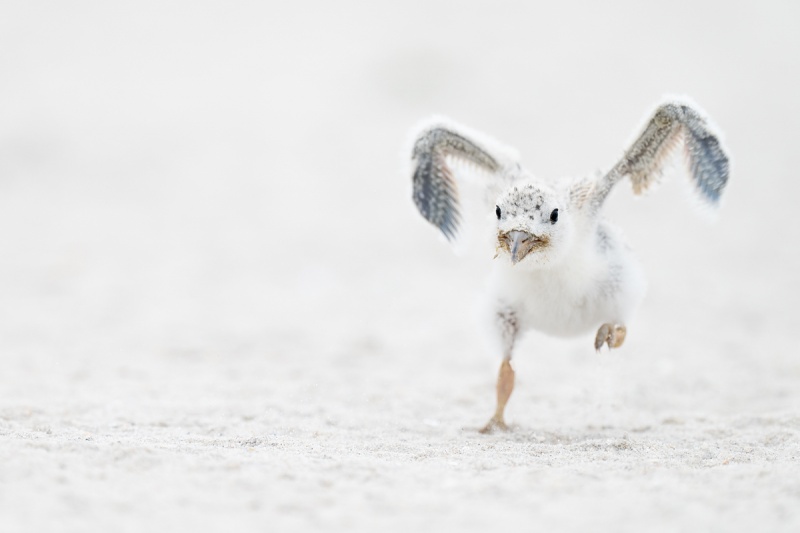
[{"x1": 411, "y1": 118, "x2": 521, "y2": 242}]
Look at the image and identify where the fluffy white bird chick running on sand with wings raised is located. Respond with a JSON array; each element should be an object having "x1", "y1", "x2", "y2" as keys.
[{"x1": 412, "y1": 100, "x2": 729, "y2": 433}]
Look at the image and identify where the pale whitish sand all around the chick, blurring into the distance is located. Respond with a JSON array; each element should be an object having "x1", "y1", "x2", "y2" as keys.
[{"x1": 0, "y1": 2, "x2": 800, "y2": 532}]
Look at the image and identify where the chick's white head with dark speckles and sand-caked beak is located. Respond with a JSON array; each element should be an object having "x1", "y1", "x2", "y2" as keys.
[{"x1": 495, "y1": 184, "x2": 573, "y2": 268}]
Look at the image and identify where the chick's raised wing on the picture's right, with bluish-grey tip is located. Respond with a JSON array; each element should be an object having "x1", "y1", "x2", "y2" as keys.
[{"x1": 573, "y1": 101, "x2": 730, "y2": 208}]
